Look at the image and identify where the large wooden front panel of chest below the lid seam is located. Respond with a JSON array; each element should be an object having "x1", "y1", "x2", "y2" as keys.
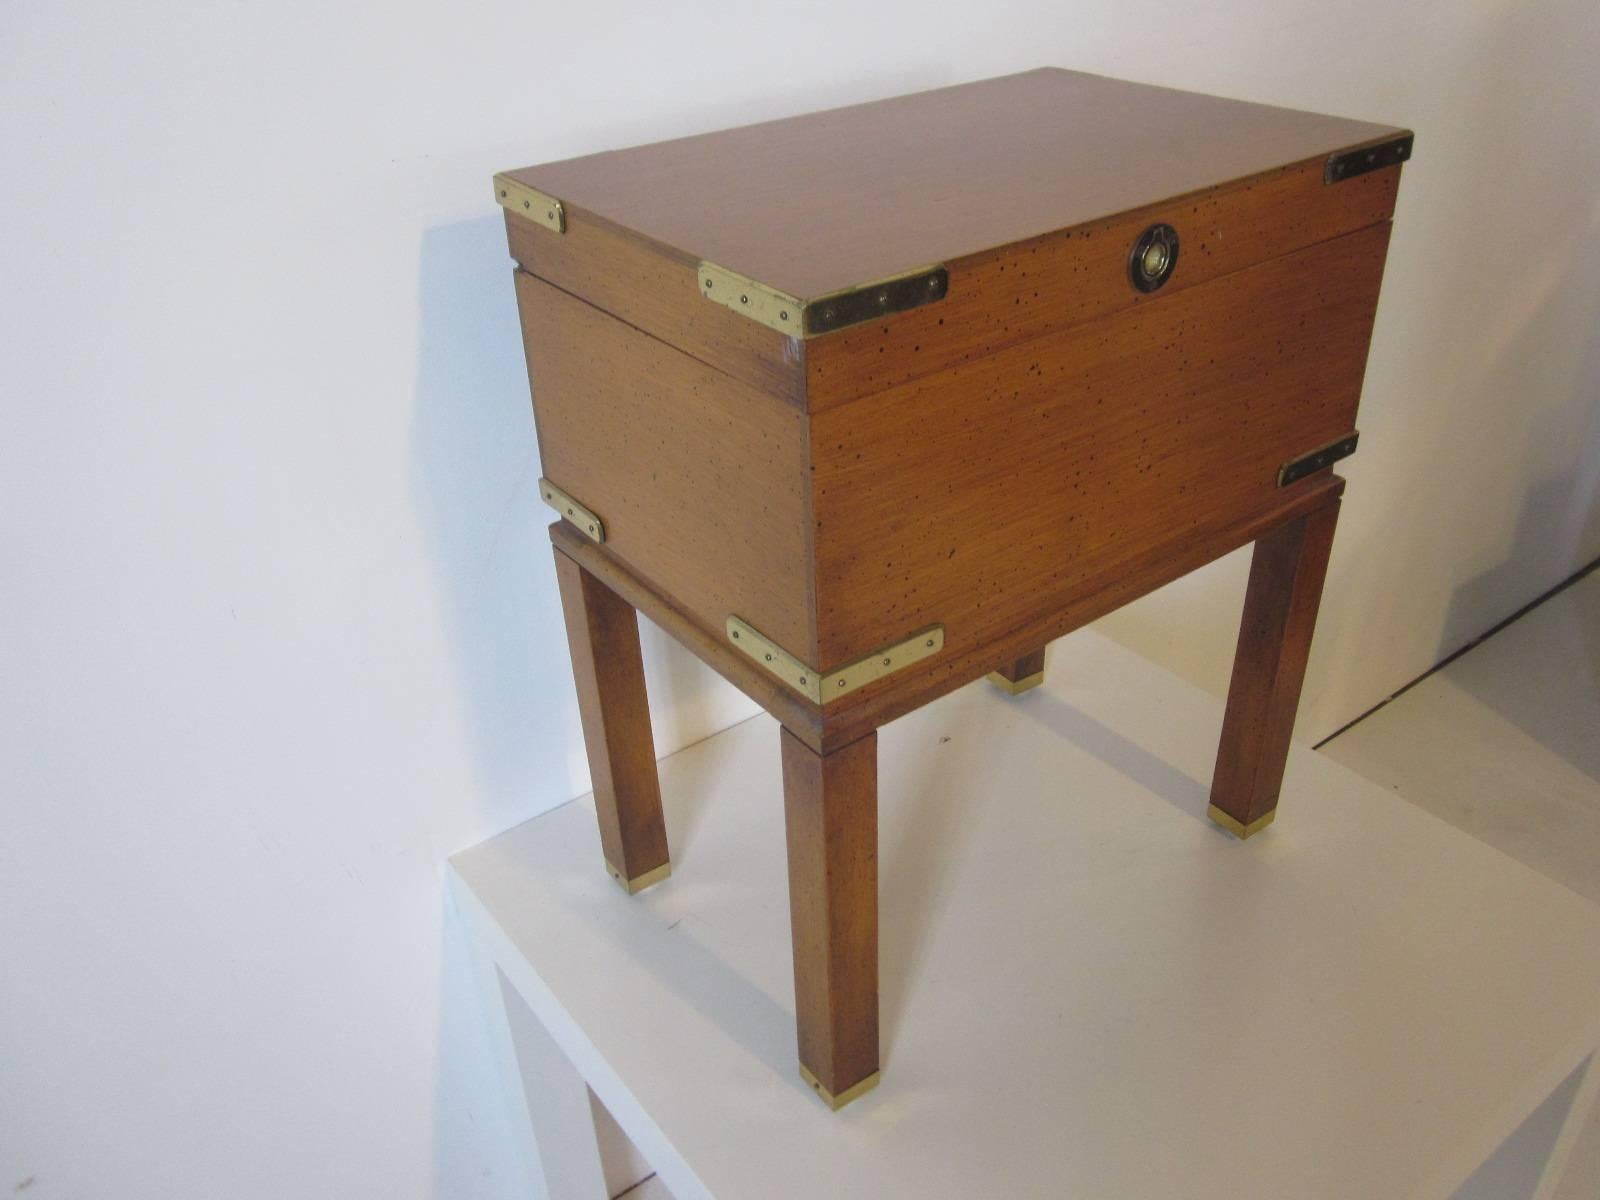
[{"x1": 811, "y1": 222, "x2": 1389, "y2": 669}]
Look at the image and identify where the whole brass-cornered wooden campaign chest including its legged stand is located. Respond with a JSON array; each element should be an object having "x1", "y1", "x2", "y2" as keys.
[{"x1": 494, "y1": 70, "x2": 1411, "y2": 1104}]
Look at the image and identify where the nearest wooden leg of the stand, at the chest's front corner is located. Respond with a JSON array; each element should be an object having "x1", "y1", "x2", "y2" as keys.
[{"x1": 782, "y1": 730, "x2": 878, "y2": 1109}]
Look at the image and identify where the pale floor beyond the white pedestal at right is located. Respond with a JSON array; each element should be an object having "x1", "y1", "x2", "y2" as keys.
[{"x1": 1323, "y1": 571, "x2": 1600, "y2": 1200}]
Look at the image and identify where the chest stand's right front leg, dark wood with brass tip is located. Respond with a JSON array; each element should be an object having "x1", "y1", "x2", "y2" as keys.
[{"x1": 1210, "y1": 501, "x2": 1339, "y2": 838}]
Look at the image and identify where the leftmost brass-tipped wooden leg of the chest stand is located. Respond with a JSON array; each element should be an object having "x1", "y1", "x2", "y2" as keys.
[{"x1": 555, "y1": 550, "x2": 672, "y2": 893}]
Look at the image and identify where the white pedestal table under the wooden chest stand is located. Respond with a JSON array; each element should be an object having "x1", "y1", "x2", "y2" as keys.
[{"x1": 453, "y1": 632, "x2": 1600, "y2": 1200}]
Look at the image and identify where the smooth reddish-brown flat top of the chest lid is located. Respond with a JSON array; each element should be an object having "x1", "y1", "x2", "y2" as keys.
[{"x1": 507, "y1": 67, "x2": 1403, "y2": 296}]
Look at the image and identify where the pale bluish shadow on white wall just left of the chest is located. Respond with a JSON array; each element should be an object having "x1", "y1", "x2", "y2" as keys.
[{"x1": 411, "y1": 213, "x2": 578, "y2": 822}]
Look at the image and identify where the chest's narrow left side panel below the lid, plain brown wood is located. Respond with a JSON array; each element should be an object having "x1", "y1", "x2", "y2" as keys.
[{"x1": 517, "y1": 272, "x2": 814, "y2": 653}]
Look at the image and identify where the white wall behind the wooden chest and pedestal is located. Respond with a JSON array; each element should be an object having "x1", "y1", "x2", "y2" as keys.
[{"x1": 0, "y1": 0, "x2": 1600, "y2": 1200}]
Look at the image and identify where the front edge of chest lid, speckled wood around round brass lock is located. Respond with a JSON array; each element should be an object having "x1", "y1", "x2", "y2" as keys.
[{"x1": 806, "y1": 158, "x2": 1400, "y2": 411}]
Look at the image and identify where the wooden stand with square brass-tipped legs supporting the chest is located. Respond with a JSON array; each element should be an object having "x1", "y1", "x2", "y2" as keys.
[{"x1": 550, "y1": 474, "x2": 1344, "y2": 1109}]
